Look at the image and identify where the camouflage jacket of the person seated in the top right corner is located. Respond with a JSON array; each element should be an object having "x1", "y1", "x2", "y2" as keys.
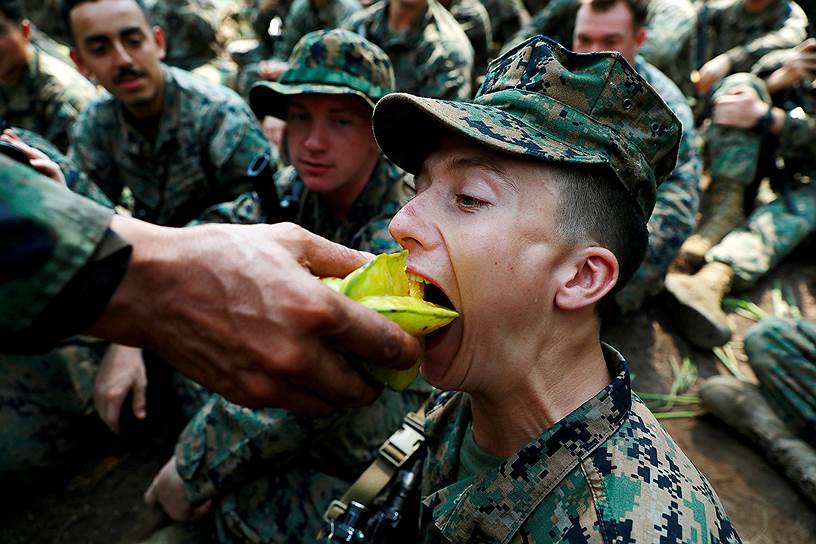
[{"x1": 698, "y1": 0, "x2": 808, "y2": 73}]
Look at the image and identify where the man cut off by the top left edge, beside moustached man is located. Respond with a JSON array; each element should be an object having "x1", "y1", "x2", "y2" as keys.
[{"x1": 0, "y1": 0, "x2": 96, "y2": 152}]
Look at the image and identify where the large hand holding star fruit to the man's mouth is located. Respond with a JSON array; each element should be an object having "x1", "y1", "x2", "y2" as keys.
[{"x1": 89, "y1": 216, "x2": 418, "y2": 415}]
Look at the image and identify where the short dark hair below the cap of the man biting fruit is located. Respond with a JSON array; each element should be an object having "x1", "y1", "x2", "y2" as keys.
[{"x1": 548, "y1": 163, "x2": 649, "y2": 292}]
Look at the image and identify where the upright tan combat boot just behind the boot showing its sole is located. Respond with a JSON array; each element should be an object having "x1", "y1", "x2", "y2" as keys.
[{"x1": 678, "y1": 178, "x2": 745, "y2": 270}]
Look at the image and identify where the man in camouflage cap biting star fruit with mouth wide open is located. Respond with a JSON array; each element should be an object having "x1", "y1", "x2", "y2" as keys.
[{"x1": 374, "y1": 36, "x2": 740, "y2": 543}]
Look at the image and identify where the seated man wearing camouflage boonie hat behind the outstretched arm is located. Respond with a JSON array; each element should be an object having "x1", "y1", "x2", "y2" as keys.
[{"x1": 143, "y1": 29, "x2": 430, "y2": 542}]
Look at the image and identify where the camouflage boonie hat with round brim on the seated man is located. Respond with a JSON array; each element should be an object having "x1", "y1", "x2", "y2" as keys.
[{"x1": 249, "y1": 29, "x2": 396, "y2": 119}]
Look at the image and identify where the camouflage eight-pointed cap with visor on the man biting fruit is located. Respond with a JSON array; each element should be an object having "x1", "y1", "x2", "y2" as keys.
[{"x1": 374, "y1": 36, "x2": 681, "y2": 219}]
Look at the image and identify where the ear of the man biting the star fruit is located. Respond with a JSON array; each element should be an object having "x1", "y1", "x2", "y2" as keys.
[{"x1": 555, "y1": 246, "x2": 619, "y2": 311}]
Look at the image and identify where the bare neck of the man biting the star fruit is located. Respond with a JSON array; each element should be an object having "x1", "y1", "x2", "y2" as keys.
[{"x1": 470, "y1": 310, "x2": 611, "y2": 457}]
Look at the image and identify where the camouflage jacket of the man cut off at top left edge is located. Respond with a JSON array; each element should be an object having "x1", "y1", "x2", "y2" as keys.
[{"x1": 0, "y1": 47, "x2": 96, "y2": 151}]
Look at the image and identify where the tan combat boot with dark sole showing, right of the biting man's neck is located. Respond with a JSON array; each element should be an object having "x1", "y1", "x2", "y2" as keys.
[{"x1": 666, "y1": 262, "x2": 734, "y2": 349}]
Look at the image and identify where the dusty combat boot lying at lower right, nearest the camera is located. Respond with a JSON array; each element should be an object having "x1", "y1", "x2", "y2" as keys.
[{"x1": 700, "y1": 376, "x2": 816, "y2": 505}]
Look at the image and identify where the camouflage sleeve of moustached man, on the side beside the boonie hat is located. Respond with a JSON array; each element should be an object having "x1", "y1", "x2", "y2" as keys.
[{"x1": 209, "y1": 96, "x2": 277, "y2": 202}]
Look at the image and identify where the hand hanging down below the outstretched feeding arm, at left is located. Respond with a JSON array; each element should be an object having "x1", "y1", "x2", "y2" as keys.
[{"x1": 94, "y1": 344, "x2": 147, "y2": 434}]
